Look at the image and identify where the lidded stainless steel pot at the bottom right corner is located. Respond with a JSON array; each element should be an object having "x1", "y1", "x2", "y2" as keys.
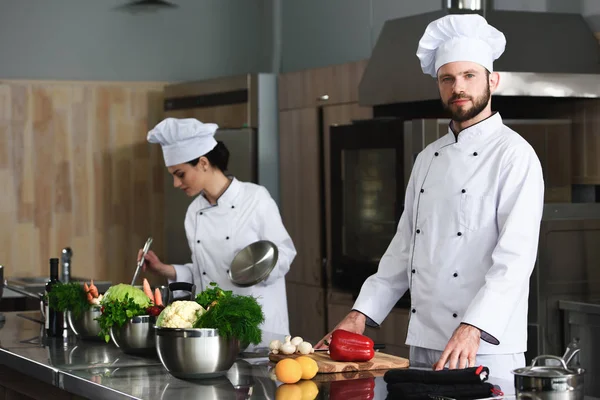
[{"x1": 512, "y1": 356, "x2": 585, "y2": 400}]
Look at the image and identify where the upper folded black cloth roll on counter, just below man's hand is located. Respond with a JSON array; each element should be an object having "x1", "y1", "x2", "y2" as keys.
[{"x1": 383, "y1": 366, "x2": 490, "y2": 385}]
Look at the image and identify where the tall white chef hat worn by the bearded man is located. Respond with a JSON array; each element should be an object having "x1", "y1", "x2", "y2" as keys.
[{"x1": 417, "y1": 14, "x2": 506, "y2": 78}]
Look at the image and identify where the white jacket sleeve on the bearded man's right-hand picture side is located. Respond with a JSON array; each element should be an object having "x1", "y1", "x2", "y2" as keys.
[{"x1": 462, "y1": 144, "x2": 544, "y2": 345}]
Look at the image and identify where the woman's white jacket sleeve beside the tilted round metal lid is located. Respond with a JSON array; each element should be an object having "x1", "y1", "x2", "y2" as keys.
[{"x1": 257, "y1": 187, "x2": 296, "y2": 286}]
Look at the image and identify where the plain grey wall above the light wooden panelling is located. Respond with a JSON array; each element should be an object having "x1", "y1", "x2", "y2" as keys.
[{"x1": 0, "y1": 0, "x2": 280, "y2": 82}]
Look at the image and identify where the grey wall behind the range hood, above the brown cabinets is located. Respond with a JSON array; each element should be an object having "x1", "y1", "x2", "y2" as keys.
[{"x1": 281, "y1": 0, "x2": 600, "y2": 72}]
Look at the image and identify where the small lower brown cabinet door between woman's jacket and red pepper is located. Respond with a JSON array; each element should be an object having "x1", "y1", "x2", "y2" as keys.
[{"x1": 286, "y1": 283, "x2": 327, "y2": 345}]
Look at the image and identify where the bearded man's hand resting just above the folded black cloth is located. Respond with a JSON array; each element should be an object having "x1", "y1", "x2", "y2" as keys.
[{"x1": 433, "y1": 324, "x2": 481, "y2": 371}]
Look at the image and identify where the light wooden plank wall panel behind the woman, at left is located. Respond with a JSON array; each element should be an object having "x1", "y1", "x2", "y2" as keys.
[{"x1": 0, "y1": 81, "x2": 164, "y2": 282}]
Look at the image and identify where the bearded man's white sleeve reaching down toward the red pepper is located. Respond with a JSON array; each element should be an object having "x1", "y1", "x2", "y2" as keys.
[{"x1": 352, "y1": 153, "x2": 422, "y2": 326}]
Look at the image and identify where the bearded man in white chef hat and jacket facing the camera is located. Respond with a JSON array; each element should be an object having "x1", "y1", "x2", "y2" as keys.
[{"x1": 318, "y1": 15, "x2": 544, "y2": 379}]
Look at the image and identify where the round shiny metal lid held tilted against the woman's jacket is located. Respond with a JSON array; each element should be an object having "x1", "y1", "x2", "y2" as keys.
[{"x1": 228, "y1": 240, "x2": 279, "y2": 287}]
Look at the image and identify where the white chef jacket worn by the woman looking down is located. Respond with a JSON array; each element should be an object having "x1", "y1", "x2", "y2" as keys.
[{"x1": 174, "y1": 178, "x2": 296, "y2": 335}]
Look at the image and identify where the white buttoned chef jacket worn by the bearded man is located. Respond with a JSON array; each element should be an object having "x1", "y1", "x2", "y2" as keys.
[{"x1": 354, "y1": 113, "x2": 544, "y2": 354}]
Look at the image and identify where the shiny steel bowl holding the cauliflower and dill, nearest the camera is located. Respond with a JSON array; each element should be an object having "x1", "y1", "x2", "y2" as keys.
[{"x1": 156, "y1": 327, "x2": 240, "y2": 379}]
